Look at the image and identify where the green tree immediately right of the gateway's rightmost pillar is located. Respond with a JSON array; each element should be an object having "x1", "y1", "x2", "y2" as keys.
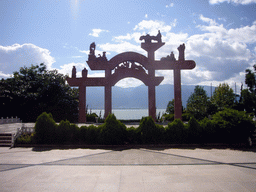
[{"x1": 187, "y1": 85, "x2": 209, "y2": 119}]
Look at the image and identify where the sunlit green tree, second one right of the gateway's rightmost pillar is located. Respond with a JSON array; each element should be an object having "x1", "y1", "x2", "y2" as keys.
[{"x1": 211, "y1": 83, "x2": 235, "y2": 110}]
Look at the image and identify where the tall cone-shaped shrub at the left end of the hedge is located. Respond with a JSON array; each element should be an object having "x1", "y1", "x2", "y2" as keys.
[{"x1": 35, "y1": 112, "x2": 56, "y2": 144}]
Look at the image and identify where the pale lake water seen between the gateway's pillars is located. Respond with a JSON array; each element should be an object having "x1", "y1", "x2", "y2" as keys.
[{"x1": 89, "y1": 109, "x2": 166, "y2": 120}]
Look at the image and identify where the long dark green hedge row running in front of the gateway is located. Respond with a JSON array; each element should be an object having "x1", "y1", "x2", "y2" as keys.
[{"x1": 22, "y1": 109, "x2": 255, "y2": 145}]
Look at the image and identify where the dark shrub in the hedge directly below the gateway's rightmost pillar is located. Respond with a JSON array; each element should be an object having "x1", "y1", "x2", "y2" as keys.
[{"x1": 166, "y1": 119, "x2": 187, "y2": 143}]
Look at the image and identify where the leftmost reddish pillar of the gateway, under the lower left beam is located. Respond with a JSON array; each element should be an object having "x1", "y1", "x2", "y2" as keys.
[{"x1": 78, "y1": 85, "x2": 86, "y2": 123}]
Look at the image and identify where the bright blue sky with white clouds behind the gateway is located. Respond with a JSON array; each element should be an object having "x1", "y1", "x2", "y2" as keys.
[{"x1": 0, "y1": 0, "x2": 256, "y2": 90}]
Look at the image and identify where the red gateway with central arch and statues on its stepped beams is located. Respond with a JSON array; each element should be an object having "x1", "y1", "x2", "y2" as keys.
[{"x1": 67, "y1": 31, "x2": 196, "y2": 123}]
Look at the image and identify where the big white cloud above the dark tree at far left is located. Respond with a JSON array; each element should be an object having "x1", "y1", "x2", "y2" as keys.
[{"x1": 0, "y1": 44, "x2": 55, "y2": 77}]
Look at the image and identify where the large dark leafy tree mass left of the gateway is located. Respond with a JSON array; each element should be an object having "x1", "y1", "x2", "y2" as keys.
[{"x1": 0, "y1": 63, "x2": 78, "y2": 122}]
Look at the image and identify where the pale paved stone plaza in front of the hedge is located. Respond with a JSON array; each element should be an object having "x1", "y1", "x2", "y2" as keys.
[{"x1": 0, "y1": 147, "x2": 256, "y2": 192}]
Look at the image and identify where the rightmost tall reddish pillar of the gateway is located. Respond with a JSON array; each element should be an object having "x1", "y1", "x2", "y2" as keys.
[{"x1": 173, "y1": 69, "x2": 182, "y2": 120}]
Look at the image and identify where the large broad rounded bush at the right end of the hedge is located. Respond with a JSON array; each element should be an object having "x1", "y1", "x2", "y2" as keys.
[{"x1": 212, "y1": 109, "x2": 255, "y2": 144}]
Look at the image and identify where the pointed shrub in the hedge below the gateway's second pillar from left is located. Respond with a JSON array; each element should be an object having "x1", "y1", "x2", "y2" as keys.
[{"x1": 99, "y1": 114, "x2": 127, "y2": 145}]
